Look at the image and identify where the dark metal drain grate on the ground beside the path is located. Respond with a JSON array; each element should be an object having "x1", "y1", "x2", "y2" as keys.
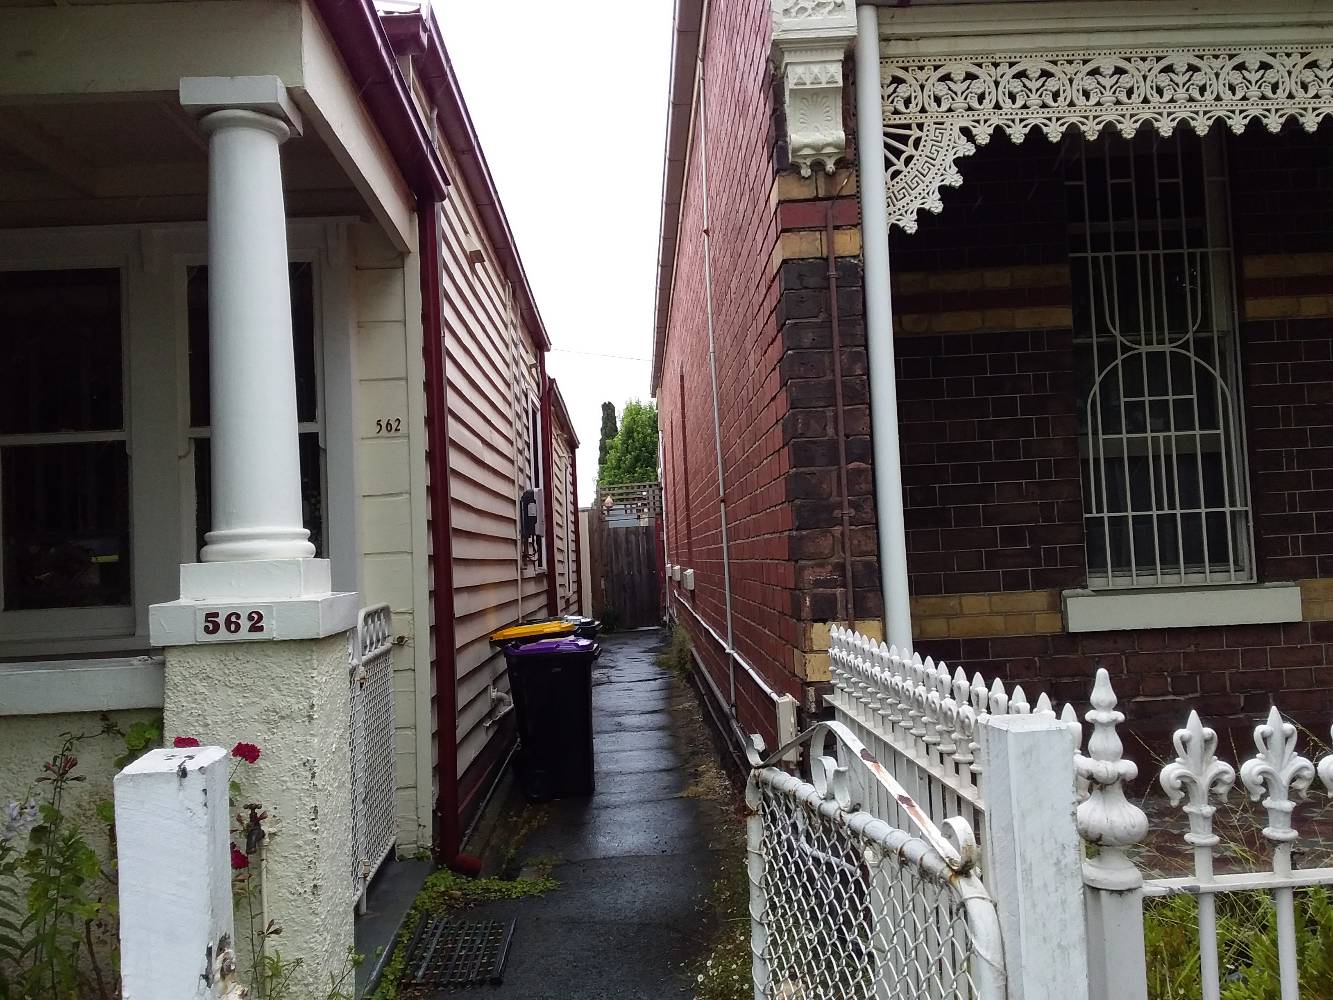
[{"x1": 403, "y1": 913, "x2": 513, "y2": 991}]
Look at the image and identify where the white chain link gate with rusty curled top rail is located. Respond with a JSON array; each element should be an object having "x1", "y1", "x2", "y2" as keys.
[{"x1": 745, "y1": 723, "x2": 1005, "y2": 1000}]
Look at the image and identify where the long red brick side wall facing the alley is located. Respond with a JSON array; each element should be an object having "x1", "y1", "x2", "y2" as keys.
[{"x1": 659, "y1": 0, "x2": 798, "y2": 739}]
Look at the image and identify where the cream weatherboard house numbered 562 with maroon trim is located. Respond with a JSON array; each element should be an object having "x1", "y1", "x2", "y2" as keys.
[{"x1": 0, "y1": 0, "x2": 581, "y2": 981}]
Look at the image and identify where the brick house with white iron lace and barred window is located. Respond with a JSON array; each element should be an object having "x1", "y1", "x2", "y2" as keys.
[{"x1": 652, "y1": 0, "x2": 1333, "y2": 740}]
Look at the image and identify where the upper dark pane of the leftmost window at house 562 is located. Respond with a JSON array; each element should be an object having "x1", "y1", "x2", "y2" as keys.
[{"x1": 0, "y1": 268, "x2": 124, "y2": 435}]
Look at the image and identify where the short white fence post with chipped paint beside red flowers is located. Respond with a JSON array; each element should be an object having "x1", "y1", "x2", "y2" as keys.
[{"x1": 115, "y1": 747, "x2": 235, "y2": 1000}]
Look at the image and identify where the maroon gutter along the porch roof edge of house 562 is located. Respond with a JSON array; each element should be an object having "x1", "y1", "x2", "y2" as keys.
[{"x1": 312, "y1": 0, "x2": 449, "y2": 201}]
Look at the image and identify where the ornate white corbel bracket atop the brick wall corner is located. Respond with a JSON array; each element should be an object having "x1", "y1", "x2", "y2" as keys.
[{"x1": 772, "y1": 0, "x2": 856, "y2": 177}]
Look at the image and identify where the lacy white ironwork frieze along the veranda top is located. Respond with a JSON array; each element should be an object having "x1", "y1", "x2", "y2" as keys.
[{"x1": 874, "y1": 47, "x2": 1333, "y2": 232}]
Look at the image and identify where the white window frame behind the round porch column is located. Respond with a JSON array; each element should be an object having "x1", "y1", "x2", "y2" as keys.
[{"x1": 0, "y1": 217, "x2": 360, "y2": 661}]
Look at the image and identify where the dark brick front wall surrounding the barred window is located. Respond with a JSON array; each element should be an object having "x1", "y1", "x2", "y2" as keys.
[{"x1": 892, "y1": 129, "x2": 1333, "y2": 752}]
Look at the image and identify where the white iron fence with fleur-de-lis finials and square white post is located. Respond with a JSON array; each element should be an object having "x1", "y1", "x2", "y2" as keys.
[{"x1": 829, "y1": 628, "x2": 1333, "y2": 1000}]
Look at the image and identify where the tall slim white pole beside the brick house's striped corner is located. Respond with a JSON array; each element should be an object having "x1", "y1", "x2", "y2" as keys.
[{"x1": 856, "y1": 5, "x2": 912, "y2": 649}]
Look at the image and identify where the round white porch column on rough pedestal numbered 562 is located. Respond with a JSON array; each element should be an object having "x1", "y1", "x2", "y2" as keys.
[{"x1": 149, "y1": 76, "x2": 360, "y2": 996}]
